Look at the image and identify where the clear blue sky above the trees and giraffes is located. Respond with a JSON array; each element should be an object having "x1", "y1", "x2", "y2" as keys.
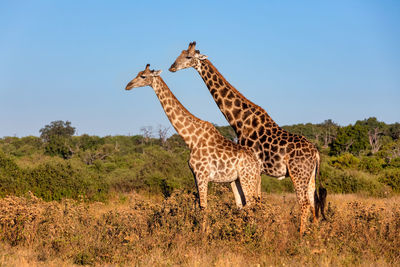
[{"x1": 0, "y1": 0, "x2": 400, "y2": 137}]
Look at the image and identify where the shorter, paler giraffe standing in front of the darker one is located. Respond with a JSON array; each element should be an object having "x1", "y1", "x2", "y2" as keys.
[{"x1": 125, "y1": 64, "x2": 261, "y2": 210}]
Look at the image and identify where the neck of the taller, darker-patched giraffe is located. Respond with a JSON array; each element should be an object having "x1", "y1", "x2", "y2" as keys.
[{"x1": 195, "y1": 59, "x2": 278, "y2": 134}]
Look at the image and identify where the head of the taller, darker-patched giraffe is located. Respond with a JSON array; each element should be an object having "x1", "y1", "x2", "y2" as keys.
[{"x1": 169, "y1": 42, "x2": 207, "y2": 72}]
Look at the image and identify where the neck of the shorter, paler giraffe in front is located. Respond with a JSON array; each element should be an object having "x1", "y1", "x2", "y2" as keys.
[{"x1": 151, "y1": 77, "x2": 204, "y2": 148}]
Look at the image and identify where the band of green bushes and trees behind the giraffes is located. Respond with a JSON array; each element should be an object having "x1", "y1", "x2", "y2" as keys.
[{"x1": 0, "y1": 118, "x2": 400, "y2": 201}]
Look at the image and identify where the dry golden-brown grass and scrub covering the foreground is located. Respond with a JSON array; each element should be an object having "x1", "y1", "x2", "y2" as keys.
[{"x1": 0, "y1": 187, "x2": 400, "y2": 266}]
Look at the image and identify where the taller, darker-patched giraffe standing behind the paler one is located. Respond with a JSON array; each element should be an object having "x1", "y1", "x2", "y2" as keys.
[{"x1": 169, "y1": 42, "x2": 326, "y2": 236}]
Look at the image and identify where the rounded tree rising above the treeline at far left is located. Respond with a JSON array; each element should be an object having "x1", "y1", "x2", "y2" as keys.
[{"x1": 39, "y1": 121, "x2": 75, "y2": 159}]
